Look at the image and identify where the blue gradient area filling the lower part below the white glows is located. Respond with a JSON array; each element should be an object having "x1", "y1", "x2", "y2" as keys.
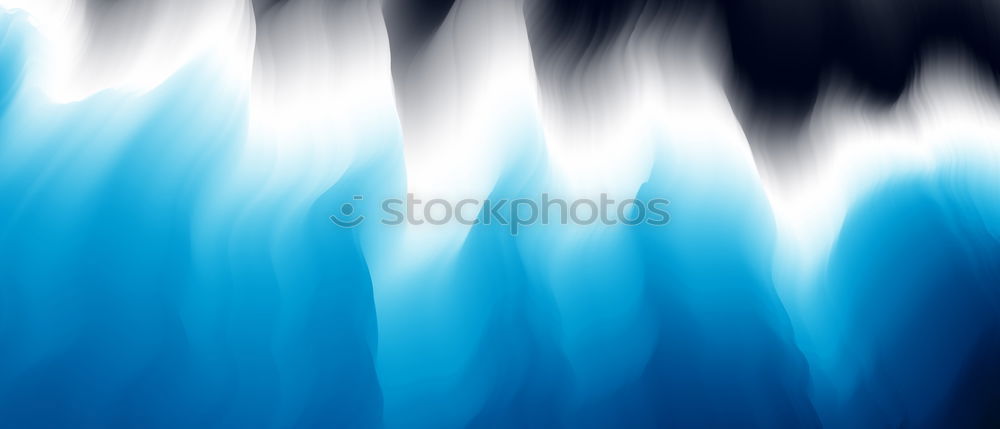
[{"x1": 0, "y1": 10, "x2": 1000, "y2": 428}]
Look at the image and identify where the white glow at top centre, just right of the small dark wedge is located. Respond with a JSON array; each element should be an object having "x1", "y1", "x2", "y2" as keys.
[{"x1": 388, "y1": 0, "x2": 540, "y2": 266}]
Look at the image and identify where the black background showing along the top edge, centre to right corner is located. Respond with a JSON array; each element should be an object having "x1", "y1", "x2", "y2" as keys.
[{"x1": 376, "y1": 0, "x2": 1000, "y2": 150}]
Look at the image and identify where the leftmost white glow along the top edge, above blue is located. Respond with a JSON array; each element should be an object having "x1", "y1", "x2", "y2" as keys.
[{"x1": 0, "y1": 0, "x2": 253, "y2": 103}]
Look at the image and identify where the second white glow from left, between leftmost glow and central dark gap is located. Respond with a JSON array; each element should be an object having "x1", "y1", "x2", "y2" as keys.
[{"x1": 245, "y1": 1, "x2": 396, "y2": 194}]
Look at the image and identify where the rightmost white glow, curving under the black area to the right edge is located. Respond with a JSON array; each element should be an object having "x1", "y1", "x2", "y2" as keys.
[{"x1": 764, "y1": 52, "x2": 1000, "y2": 291}]
